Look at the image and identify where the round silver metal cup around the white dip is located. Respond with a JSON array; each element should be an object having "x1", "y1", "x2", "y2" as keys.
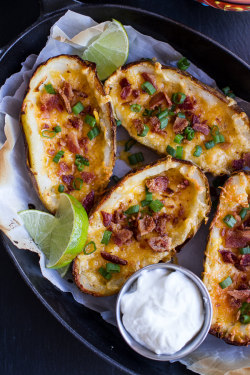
[{"x1": 116, "y1": 263, "x2": 212, "y2": 361}]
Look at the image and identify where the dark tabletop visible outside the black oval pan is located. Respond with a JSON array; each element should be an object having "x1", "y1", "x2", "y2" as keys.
[{"x1": 0, "y1": 0, "x2": 250, "y2": 375}]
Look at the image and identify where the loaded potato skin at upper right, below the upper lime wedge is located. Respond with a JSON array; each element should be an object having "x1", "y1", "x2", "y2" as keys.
[{"x1": 104, "y1": 61, "x2": 250, "y2": 175}]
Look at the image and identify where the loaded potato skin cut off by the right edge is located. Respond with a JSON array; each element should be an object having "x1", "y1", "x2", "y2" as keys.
[{"x1": 203, "y1": 171, "x2": 250, "y2": 345}]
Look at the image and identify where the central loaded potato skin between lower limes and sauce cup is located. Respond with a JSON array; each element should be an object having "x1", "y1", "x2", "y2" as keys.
[{"x1": 73, "y1": 157, "x2": 210, "y2": 296}]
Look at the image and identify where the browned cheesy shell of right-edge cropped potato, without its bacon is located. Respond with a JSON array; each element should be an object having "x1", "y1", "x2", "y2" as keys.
[{"x1": 203, "y1": 171, "x2": 250, "y2": 346}]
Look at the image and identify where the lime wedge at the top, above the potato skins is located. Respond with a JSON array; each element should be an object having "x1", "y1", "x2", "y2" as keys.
[{"x1": 82, "y1": 19, "x2": 129, "y2": 80}]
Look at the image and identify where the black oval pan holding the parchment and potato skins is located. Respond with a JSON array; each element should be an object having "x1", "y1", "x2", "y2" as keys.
[{"x1": 0, "y1": 0, "x2": 250, "y2": 375}]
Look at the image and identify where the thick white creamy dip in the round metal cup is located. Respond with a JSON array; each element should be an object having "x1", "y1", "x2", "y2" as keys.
[{"x1": 121, "y1": 269, "x2": 204, "y2": 354}]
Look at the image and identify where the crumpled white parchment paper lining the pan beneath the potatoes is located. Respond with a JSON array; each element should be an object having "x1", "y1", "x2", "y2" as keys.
[{"x1": 0, "y1": 11, "x2": 250, "y2": 375}]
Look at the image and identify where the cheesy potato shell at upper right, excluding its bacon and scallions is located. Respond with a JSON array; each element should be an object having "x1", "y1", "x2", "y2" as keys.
[{"x1": 104, "y1": 61, "x2": 250, "y2": 175}]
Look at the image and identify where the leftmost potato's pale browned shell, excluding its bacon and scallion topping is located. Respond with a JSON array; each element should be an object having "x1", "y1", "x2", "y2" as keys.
[{"x1": 20, "y1": 55, "x2": 116, "y2": 213}]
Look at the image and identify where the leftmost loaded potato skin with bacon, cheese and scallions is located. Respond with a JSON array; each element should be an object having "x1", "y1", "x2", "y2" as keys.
[{"x1": 21, "y1": 55, "x2": 116, "y2": 213}]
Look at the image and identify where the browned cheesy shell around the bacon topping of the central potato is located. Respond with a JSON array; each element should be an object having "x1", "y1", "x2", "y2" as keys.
[{"x1": 73, "y1": 157, "x2": 211, "y2": 296}]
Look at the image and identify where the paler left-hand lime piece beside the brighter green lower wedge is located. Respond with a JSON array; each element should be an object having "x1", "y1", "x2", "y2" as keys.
[{"x1": 18, "y1": 210, "x2": 56, "y2": 258}]
